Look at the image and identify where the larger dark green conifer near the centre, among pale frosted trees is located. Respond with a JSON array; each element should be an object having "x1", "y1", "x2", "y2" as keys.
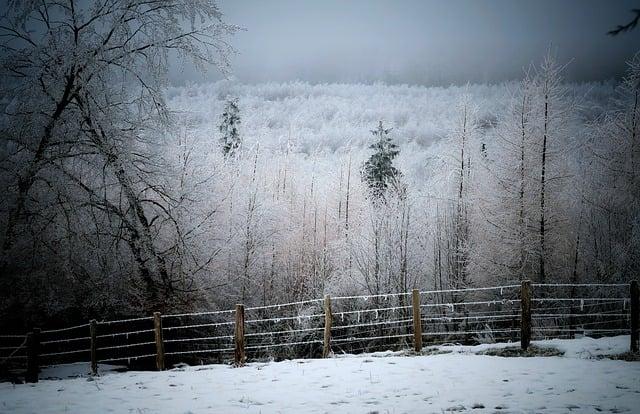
[{"x1": 362, "y1": 121, "x2": 402, "y2": 199}]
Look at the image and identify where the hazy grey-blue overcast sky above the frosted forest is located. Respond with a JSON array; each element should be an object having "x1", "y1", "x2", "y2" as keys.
[{"x1": 171, "y1": 0, "x2": 640, "y2": 85}]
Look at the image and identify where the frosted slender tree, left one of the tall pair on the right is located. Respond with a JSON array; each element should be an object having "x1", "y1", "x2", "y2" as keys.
[{"x1": 473, "y1": 73, "x2": 538, "y2": 282}]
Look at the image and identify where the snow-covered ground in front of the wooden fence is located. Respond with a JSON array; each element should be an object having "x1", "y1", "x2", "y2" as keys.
[{"x1": 0, "y1": 336, "x2": 640, "y2": 413}]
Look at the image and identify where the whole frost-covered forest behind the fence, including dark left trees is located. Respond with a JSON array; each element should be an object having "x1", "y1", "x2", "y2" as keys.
[{"x1": 0, "y1": 0, "x2": 640, "y2": 329}]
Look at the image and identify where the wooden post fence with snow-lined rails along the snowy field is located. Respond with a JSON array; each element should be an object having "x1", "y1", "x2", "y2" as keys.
[{"x1": 0, "y1": 281, "x2": 640, "y2": 382}]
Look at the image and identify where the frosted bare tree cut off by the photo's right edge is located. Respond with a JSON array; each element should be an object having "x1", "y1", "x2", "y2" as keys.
[{"x1": 588, "y1": 53, "x2": 640, "y2": 280}]
